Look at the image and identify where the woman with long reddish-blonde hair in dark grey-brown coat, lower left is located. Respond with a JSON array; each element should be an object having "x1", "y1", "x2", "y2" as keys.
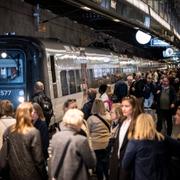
[{"x1": 0, "y1": 102, "x2": 47, "y2": 180}]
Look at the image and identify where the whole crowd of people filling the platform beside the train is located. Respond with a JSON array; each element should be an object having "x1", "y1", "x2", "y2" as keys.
[{"x1": 0, "y1": 70, "x2": 180, "y2": 180}]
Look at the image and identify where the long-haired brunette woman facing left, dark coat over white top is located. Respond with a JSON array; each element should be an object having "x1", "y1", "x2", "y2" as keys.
[{"x1": 107, "y1": 95, "x2": 140, "y2": 180}]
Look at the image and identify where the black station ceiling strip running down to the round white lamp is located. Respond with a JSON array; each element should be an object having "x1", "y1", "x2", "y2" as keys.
[{"x1": 25, "y1": 0, "x2": 179, "y2": 59}]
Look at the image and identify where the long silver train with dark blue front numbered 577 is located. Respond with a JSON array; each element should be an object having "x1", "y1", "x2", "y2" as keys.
[{"x1": 0, "y1": 35, "x2": 167, "y2": 117}]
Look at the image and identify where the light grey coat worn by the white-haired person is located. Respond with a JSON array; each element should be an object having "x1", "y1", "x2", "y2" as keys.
[{"x1": 49, "y1": 127, "x2": 96, "y2": 180}]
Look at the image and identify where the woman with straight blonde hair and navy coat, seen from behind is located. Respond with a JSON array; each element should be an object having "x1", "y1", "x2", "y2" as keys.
[{"x1": 122, "y1": 113, "x2": 179, "y2": 180}]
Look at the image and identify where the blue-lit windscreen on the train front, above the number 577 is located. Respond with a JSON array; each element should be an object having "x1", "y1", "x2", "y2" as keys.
[{"x1": 0, "y1": 50, "x2": 25, "y2": 84}]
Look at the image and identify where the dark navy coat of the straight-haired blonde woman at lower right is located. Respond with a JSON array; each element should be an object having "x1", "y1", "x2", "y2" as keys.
[{"x1": 122, "y1": 137, "x2": 180, "y2": 180}]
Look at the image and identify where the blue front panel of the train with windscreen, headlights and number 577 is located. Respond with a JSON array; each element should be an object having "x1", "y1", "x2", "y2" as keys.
[{"x1": 0, "y1": 49, "x2": 26, "y2": 107}]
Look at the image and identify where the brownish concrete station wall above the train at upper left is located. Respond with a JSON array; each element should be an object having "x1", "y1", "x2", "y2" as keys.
[{"x1": 0, "y1": 0, "x2": 98, "y2": 46}]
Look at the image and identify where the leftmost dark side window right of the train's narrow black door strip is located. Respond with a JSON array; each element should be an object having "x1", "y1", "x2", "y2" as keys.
[{"x1": 60, "y1": 70, "x2": 69, "y2": 96}]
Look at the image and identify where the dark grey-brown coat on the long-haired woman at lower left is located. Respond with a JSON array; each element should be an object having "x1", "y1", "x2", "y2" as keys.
[{"x1": 0, "y1": 127, "x2": 47, "y2": 180}]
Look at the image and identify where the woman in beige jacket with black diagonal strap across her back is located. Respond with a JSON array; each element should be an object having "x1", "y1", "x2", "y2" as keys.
[{"x1": 87, "y1": 99, "x2": 111, "y2": 180}]
